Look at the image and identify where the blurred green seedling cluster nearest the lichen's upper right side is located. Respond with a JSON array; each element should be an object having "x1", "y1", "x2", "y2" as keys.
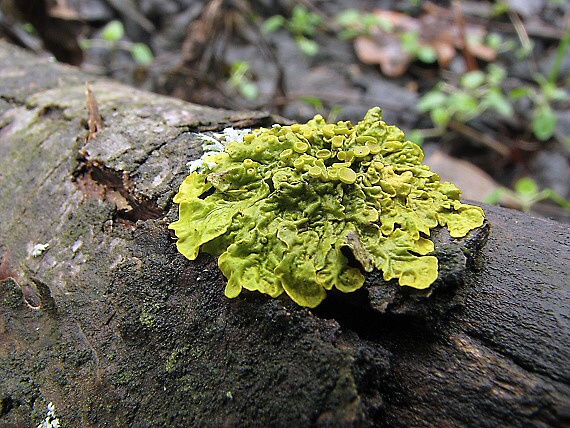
[{"x1": 418, "y1": 64, "x2": 513, "y2": 130}]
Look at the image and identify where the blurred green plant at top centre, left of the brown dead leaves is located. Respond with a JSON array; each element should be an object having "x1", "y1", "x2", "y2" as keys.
[{"x1": 262, "y1": 5, "x2": 323, "y2": 56}]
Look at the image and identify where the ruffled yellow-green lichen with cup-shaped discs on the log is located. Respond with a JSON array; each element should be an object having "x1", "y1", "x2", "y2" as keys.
[{"x1": 169, "y1": 107, "x2": 484, "y2": 307}]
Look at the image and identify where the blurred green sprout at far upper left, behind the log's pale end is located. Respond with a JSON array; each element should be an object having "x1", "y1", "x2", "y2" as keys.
[{"x1": 80, "y1": 21, "x2": 154, "y2": 65}]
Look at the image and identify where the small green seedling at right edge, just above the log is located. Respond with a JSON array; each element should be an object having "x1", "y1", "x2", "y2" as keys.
[{"x1": 484, "y1": 177, "x2": 570, "y2": 212}]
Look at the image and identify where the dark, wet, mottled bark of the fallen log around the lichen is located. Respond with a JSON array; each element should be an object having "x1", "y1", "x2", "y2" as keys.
[{"x1": 0, "y1": 43, "x2": 570, "y2": 427}]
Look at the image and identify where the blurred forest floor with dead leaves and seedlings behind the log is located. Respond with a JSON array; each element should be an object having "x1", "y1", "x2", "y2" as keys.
[{"x1": 0, "y1": 0, "x2": 570, "y2": 222}]
